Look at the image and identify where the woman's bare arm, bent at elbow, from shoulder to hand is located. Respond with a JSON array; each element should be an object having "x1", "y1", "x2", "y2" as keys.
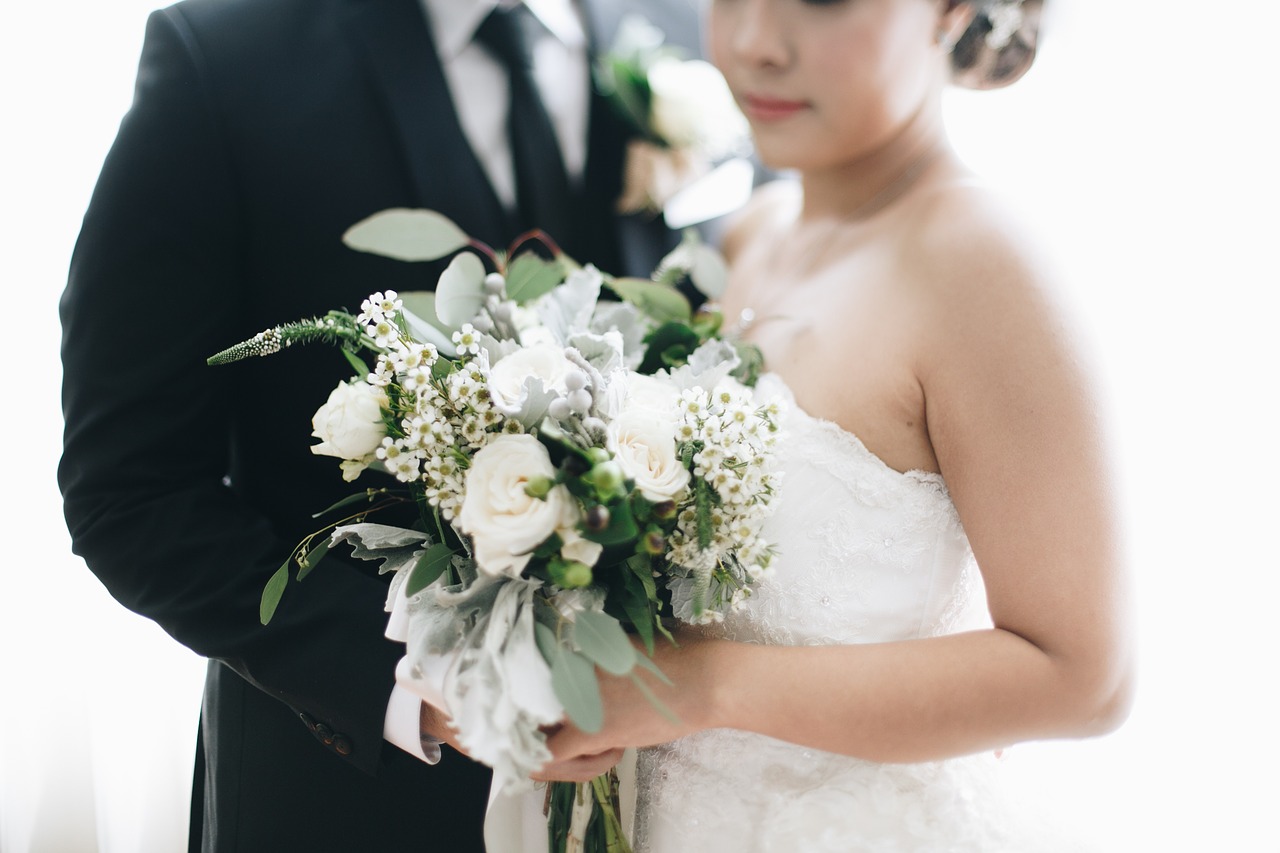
[{"x1": 552, "y1": 194, "x2": 1132, "y2": 762}]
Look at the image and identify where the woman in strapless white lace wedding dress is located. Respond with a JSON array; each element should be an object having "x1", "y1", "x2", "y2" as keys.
[{"x1": 527, "y1": 0, "x2": 1132, "y2": 853}]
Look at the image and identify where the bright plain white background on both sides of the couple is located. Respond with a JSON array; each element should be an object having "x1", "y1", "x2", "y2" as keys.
[{"x1": 0, "y1": 0, "x2": 1280, "y2": 853}]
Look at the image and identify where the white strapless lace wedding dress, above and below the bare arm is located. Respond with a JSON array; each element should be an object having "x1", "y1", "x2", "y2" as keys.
[{"x1": 636, "y1": 377, "x2": 1029, "y2": 853}]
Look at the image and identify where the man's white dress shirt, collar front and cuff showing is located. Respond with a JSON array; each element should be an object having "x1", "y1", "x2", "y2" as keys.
[{"x1": 383, "y1": 0, "x2": 591, "y2": 765}]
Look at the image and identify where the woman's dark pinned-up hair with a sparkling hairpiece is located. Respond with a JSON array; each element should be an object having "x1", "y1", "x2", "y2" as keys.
[{"x1": 947, "y1": 0, "x2": 1043, "y2": 88}]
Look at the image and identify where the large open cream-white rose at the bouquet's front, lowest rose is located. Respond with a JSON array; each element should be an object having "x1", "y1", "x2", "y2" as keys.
[{"x1": 457, "y1": 434, "x2": 575, "y2": 578}]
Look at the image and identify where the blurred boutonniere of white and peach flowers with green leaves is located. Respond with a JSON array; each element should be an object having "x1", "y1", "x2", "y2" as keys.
[{"x1": 595, "y1": 15, "x2": 750, "y2": 215}]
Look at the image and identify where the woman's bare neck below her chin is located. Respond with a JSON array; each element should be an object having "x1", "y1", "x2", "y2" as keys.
[{"x1": 800, "y1": 103, "x2": 951, "y2": 222}]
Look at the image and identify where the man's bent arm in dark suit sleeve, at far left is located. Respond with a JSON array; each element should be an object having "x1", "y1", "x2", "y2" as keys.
[{"x1": 59, "y1": 9, "x2": 401, "y2": 771}]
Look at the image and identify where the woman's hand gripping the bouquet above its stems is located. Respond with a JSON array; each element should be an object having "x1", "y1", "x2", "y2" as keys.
[{"x1": 547, "y1": 631, "x2": 728, "y2": 762}]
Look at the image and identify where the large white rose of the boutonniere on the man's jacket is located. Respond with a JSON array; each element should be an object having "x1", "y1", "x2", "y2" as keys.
[{"x1": 649, "y1": 58, "x2": 746, "y2": 158}]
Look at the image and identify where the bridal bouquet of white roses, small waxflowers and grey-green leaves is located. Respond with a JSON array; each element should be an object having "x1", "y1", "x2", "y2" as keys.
[{"x1": 210, "y1": 210, "x2": 778, "y2": 850}]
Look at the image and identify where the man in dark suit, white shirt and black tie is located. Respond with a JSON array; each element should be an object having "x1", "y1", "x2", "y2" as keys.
[{"x1": 59, "y1": 0, "x2": 696, "y2": 853}]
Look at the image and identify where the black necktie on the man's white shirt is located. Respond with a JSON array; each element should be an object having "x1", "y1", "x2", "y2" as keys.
[{"x1": 475, "y1": 4, "x2": 572, "y2": 245}]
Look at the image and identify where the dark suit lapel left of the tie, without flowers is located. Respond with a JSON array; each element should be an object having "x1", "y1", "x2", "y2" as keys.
[{"x1": 344, "y1": 0, "x2": 512, "y2": 246}]
